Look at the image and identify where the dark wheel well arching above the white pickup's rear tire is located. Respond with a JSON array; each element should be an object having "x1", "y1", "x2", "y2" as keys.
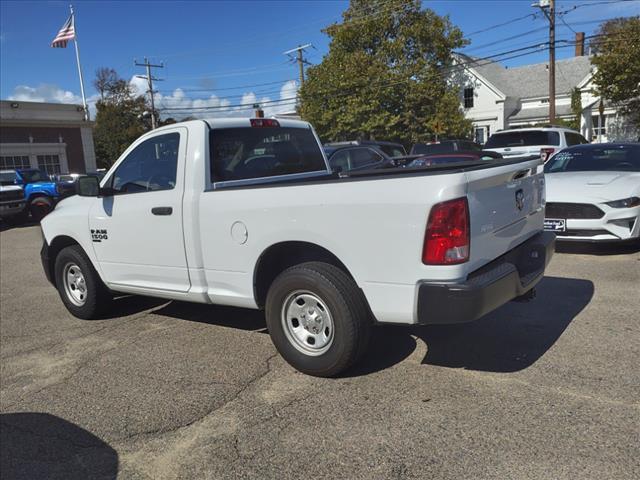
[{"x1": 253, "y1": 242, "x2": 353, "y2": 307}]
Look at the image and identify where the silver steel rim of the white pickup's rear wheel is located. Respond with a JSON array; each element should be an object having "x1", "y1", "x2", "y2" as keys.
[{"x1": 282, "y1": 290, "x2": 334, "y2": 356}]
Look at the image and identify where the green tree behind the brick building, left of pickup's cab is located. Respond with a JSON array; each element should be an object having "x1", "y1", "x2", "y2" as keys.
[{"x1": 93, "y1": 68, "x2": 148, "y2": 168}]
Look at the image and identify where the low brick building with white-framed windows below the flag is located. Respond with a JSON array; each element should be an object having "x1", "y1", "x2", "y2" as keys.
[{"x1": 0, "y1": 100, "x2": 96, "y2": 174}]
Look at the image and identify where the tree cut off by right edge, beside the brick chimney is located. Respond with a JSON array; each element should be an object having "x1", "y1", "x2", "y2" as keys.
[{"x1": 591, "y1": 16, "x2": 640, "y2": 128}]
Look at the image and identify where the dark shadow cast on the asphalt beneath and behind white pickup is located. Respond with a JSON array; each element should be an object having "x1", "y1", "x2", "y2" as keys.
[{"x1": 100, "y1": 277, "x2": 594, "y2": 377}]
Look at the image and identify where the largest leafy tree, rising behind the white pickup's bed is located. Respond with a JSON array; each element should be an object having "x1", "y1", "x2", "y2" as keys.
[{"x1": 300, "y1": 0, "x2": 471, "y2": 143}]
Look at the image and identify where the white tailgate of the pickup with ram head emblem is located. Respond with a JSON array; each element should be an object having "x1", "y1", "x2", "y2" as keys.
[{"x1": 465, "y1": 159, "x2": 545, "y2": 272}]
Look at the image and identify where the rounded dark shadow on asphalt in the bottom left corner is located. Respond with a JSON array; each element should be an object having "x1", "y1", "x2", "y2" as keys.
[{"x1": 0, "y1": 413, "x2": 118, "y2": 480}]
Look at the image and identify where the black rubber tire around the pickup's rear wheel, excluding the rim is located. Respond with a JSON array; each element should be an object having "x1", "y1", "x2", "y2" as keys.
[{"x1": 265, "y1": 262, "x2": 372, "y2": 377}]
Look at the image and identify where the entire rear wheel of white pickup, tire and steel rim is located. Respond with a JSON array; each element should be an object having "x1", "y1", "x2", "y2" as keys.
[{"x1": 265, "y1": 262, "x2": 371, "y2": 377}]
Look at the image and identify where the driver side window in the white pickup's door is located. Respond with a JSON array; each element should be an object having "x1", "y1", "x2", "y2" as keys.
[{"x1": 110, "y1": 133, "x2": 180, "y2": 194}]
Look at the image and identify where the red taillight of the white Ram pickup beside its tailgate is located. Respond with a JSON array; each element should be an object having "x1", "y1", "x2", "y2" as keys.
[{"x1": 422, "y1": 198, "x2": 470, "y2": 265}]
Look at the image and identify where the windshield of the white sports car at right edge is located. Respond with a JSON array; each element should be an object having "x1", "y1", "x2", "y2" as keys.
[{"x1": 544, "y1": 145, "x2": 640, "y2": 173}]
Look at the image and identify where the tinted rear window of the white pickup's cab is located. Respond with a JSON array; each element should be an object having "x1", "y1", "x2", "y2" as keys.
[{"x1": 210, "y1": 127, "x2": 327, "y2": 182}]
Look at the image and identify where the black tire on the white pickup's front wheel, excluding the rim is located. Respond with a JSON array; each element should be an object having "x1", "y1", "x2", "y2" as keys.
[{"x1": 55, "y1": 245, "x2": 112, "y2": 320}]
